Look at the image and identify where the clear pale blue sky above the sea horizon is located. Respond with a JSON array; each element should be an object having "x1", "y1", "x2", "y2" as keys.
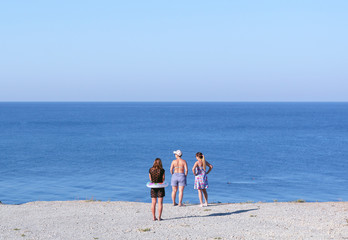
[{"x1": 0, "y1": 0, "x2": 348, "y2": 101}]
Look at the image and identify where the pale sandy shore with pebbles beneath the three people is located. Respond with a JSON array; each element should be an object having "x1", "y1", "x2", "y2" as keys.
[{"x1": 0, "y1": 201, "x2": 348, "y2": 240}]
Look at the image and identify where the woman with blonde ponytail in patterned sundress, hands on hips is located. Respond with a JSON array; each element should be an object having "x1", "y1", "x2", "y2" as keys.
[{"x1": 192, "y1": 152, "x2": 213, "y2": 207}]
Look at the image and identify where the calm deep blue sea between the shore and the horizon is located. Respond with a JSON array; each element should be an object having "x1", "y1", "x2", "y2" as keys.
[{"x1": 0, "y1": 103, "x2": 348, "y2": 204}]
